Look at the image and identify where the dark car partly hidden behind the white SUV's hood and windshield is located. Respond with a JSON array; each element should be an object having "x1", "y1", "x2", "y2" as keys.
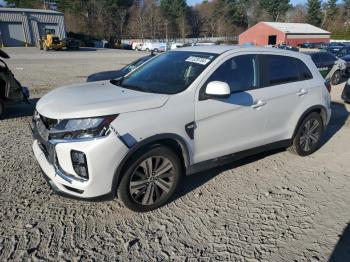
[{"x1": 86, "y1": 53, "x2": 155, "y2": 82}]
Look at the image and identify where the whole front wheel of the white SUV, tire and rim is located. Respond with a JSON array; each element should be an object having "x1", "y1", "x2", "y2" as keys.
[{"x1": 117, "y1": 146, "x2": 182, "y2": 212}]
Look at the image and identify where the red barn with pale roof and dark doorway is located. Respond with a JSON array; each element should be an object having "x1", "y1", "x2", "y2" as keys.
[{"x1": 239, "y1": 22, "x2": 330, "y2": 46}]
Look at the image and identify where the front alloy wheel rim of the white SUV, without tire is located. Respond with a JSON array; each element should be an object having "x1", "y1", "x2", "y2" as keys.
[{"x1": 129, "y1": 156, "x2": 175, "y2": 205}]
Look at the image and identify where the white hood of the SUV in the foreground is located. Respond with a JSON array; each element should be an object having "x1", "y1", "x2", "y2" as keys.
[{"x1": 36, "y1": 81, "x2": 169, "y2": 119}]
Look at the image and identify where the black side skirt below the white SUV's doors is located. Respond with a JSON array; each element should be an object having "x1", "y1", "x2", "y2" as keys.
[{"x1": 186, "y1": 139, "x2": 292, "y2": 175}]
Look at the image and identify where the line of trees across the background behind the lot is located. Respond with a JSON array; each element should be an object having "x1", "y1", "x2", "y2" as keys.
[{"x1": 6, "y1": 0, "x2": 350, "y2": 41}]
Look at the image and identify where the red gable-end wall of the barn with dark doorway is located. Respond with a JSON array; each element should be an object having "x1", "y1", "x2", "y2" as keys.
[{"x1": 239, "y1": 23, "x2": 285, "y2": 46}]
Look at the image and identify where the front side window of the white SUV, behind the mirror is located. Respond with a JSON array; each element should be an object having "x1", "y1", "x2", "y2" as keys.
[{"x1": 206, "y1": 55, "x2": 259, "y2": 94}]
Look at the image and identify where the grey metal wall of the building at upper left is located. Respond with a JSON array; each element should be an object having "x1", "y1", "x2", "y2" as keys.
[{"x1": 0, "y1": 11, "x2": 66, "y2": 46}]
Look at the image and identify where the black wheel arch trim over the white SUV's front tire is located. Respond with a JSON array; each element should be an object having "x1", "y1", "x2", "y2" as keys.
[{"x1": 111, "y1": 133, "x2": 190, "y2": 195}]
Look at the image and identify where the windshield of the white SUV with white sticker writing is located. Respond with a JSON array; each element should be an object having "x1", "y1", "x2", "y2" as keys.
[{"x1": 119, "y1": 51, "x2": 217, "y2": 94}]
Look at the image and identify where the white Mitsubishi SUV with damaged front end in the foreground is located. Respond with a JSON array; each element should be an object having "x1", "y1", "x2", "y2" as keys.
[{"x1": 33, "y1": 46, "x2": 331, "y2": 211}]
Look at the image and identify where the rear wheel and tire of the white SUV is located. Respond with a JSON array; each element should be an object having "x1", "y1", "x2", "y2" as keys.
[{"x1": 288, "y1": 112, "x2": 324, "y2": 156}]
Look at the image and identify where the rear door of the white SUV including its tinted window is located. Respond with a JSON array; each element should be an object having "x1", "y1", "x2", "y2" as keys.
[{"x1": 262, "y1": 55, "x2": 312, "y2": 143}]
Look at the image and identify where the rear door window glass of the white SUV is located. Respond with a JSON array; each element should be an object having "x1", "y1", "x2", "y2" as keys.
[{"x1": 266, "y1": 55, "x2": 300, "y2": 86}]
